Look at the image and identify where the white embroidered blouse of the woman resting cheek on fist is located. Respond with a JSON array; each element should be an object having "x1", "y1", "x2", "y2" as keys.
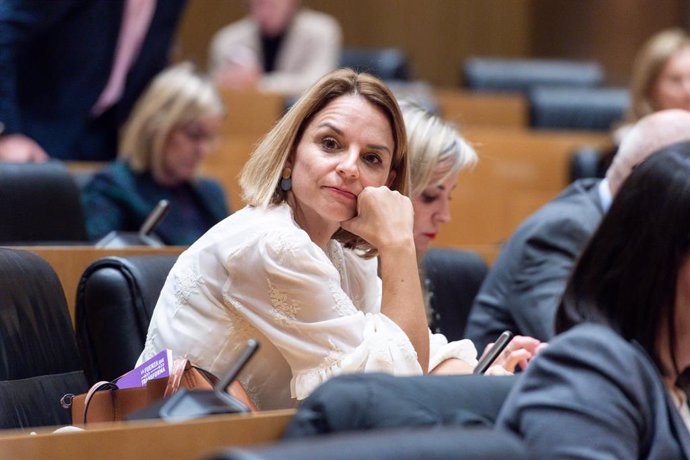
[{"x1": 138, "y1": 204, "x2": 476, "y2": 409}]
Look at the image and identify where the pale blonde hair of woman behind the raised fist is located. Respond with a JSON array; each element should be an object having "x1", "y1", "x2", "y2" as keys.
[{"x1": 400, "y1": 101, "x2": 477, "y2": 196}]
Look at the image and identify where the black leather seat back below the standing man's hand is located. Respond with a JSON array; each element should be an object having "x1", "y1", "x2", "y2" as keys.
[{"x1": 0, "y1": 161, "x2": 88, "y2": 244}]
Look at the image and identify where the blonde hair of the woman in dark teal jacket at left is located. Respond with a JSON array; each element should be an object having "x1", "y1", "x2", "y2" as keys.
[{"x1": 118, "y1": 62, "x2": 225, "y2": 177}]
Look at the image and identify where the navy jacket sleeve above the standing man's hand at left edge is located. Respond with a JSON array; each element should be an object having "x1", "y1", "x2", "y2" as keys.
[{"x1": 0, "y1": 0, "x2": 77, "y2": 133}]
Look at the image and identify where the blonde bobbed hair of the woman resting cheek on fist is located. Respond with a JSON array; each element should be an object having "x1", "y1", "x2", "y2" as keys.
[{"x1": 240, "y1": 69, "x2": 409, "y2": 256}]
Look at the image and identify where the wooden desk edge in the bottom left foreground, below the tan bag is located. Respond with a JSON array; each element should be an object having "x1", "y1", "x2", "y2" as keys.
[{"x1": 0, "y1": 410, "x2": 295, "y2": 460}]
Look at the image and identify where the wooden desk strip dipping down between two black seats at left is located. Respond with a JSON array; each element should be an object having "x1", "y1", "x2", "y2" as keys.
[{"x1": 11, "y1": 246, "x2": 186, "y2": 324}]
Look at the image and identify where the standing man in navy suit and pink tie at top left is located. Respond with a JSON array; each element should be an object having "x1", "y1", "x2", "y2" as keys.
[{"x1": 0, "y1": 0, "x2": 185, "y2": 161}]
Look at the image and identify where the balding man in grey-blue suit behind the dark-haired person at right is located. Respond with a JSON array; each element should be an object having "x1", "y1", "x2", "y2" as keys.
[{"x1": 465, "y1": 110, "x2": 690, "y2": 350}]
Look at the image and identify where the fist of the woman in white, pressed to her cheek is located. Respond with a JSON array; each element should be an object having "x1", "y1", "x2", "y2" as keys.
[{"x1": 340, "y1": 186, "x2": 414, "y2": 251}]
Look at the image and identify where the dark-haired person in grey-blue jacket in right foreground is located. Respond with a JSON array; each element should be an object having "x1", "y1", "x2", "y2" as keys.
[{"x1": 497, "y1": 142, "x2": 690, "y2": 459}]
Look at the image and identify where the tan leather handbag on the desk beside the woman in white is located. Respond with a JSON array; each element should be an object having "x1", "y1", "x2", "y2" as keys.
[{"x1": 71, "y1": 359, "x2": 256, "y2": 425}]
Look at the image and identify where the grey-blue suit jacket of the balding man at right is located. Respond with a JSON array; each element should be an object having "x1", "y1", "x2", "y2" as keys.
[{"x1": 465, "y1": 179, "x2": 604, "y2": 350}]
